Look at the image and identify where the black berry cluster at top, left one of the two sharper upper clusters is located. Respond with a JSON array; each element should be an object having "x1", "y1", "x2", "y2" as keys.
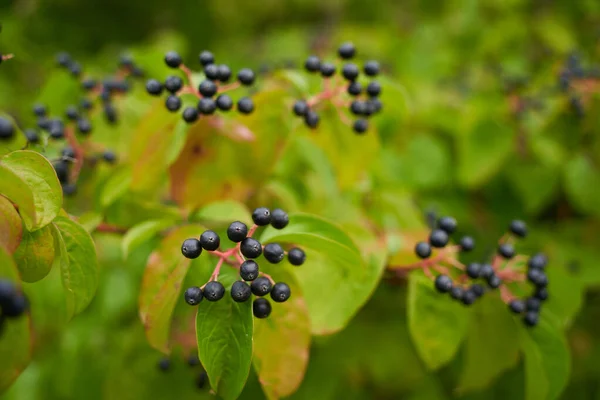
[{"x1": 146, "y1": 51, "x2": 255, "y2": 123}]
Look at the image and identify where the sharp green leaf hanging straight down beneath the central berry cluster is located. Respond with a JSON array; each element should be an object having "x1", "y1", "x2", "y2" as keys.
[{"x1": 196, "y1": 268, "x2": 253, "y2": 400}]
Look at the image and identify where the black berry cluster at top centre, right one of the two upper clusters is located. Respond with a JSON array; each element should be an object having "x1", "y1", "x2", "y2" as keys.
[{"x1": 293, "y1": 42, "x2": 382, "y2": 134}]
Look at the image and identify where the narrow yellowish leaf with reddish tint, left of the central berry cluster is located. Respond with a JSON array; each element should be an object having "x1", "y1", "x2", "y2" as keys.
[{"x1": 139, "y1": 225, "x2": 203, "y2": 353}]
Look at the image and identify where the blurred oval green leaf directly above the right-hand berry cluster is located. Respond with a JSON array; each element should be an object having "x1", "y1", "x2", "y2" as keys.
[{"x1": 457, "y1": 120, "x2": 515, "y2": 187}]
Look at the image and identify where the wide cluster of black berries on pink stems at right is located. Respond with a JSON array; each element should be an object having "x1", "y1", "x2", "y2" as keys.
[{"x1": 415, "y1": 217, "x2": 548, "y2": 326}]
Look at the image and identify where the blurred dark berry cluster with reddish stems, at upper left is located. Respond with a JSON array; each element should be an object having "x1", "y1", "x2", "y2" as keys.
[{"x1": 56, "y1": 52, "x2": 144, "y2": 124}]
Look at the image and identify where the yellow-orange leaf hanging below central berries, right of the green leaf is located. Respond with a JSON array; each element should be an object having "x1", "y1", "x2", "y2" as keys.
[{"x1": 253, "y1": 269, "x2": 310, "y2": 399}]
